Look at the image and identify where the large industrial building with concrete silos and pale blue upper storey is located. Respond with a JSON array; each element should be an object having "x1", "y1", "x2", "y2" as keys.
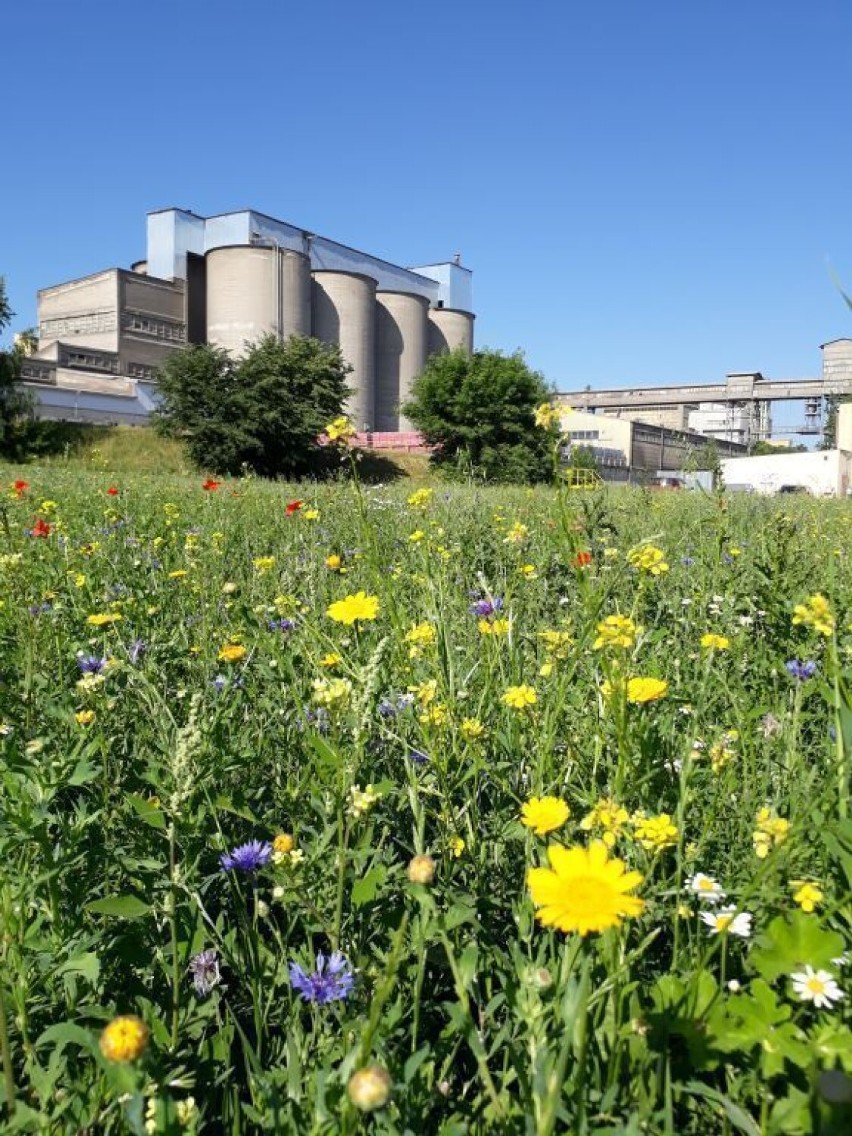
[{"x1": 23, "y1": 209, "x2": 475, "y2": 432}]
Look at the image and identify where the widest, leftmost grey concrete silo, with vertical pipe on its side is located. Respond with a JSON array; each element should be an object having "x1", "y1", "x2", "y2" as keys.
[{"x1": 206, "y1": 244, "x2": 310, "y2": 354}]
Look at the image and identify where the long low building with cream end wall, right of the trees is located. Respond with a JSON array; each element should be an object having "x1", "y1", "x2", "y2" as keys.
[{"x1": 559, "y1": 406, "x2": 747, "y2": 483}]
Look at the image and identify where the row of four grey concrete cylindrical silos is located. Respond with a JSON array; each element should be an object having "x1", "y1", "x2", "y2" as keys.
[{"x1": 204, "y1": 244, "x2": 474, "y2": 432}]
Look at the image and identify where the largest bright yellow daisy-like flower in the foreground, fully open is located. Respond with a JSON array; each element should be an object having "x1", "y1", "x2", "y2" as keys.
[{"x1": 527, "y1": 841, "x2": 644, "y2": 935}]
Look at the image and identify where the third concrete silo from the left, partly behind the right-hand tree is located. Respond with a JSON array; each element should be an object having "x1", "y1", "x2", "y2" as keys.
[{"x1": 375, "y1": 292, "x2": 429, "y2": 431}]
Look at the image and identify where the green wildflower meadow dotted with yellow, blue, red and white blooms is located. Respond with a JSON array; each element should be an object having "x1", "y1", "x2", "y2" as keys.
[{"x1": 0, "y1": 447, "x2": 852, "y2": 1136}]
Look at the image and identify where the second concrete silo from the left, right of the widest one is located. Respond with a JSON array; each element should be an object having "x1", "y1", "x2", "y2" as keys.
[{"x1": 311, "y1": 270, "x2": 376, "y2": 431}]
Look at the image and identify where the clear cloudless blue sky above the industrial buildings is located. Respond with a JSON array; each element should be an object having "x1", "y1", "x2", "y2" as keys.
[{"x1": 0, "y1": 0, "x2": 852, "y2": 433}]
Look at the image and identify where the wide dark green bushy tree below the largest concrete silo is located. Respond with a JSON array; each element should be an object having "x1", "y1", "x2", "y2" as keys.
[{"x1": 153, "y1": 335, "x2": 351, "y2": 477}]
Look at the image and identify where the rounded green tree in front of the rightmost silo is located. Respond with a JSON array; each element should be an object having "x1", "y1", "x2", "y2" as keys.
[{"x1": 403, "y1": 349, "x2": 556, "y2": 482}]
